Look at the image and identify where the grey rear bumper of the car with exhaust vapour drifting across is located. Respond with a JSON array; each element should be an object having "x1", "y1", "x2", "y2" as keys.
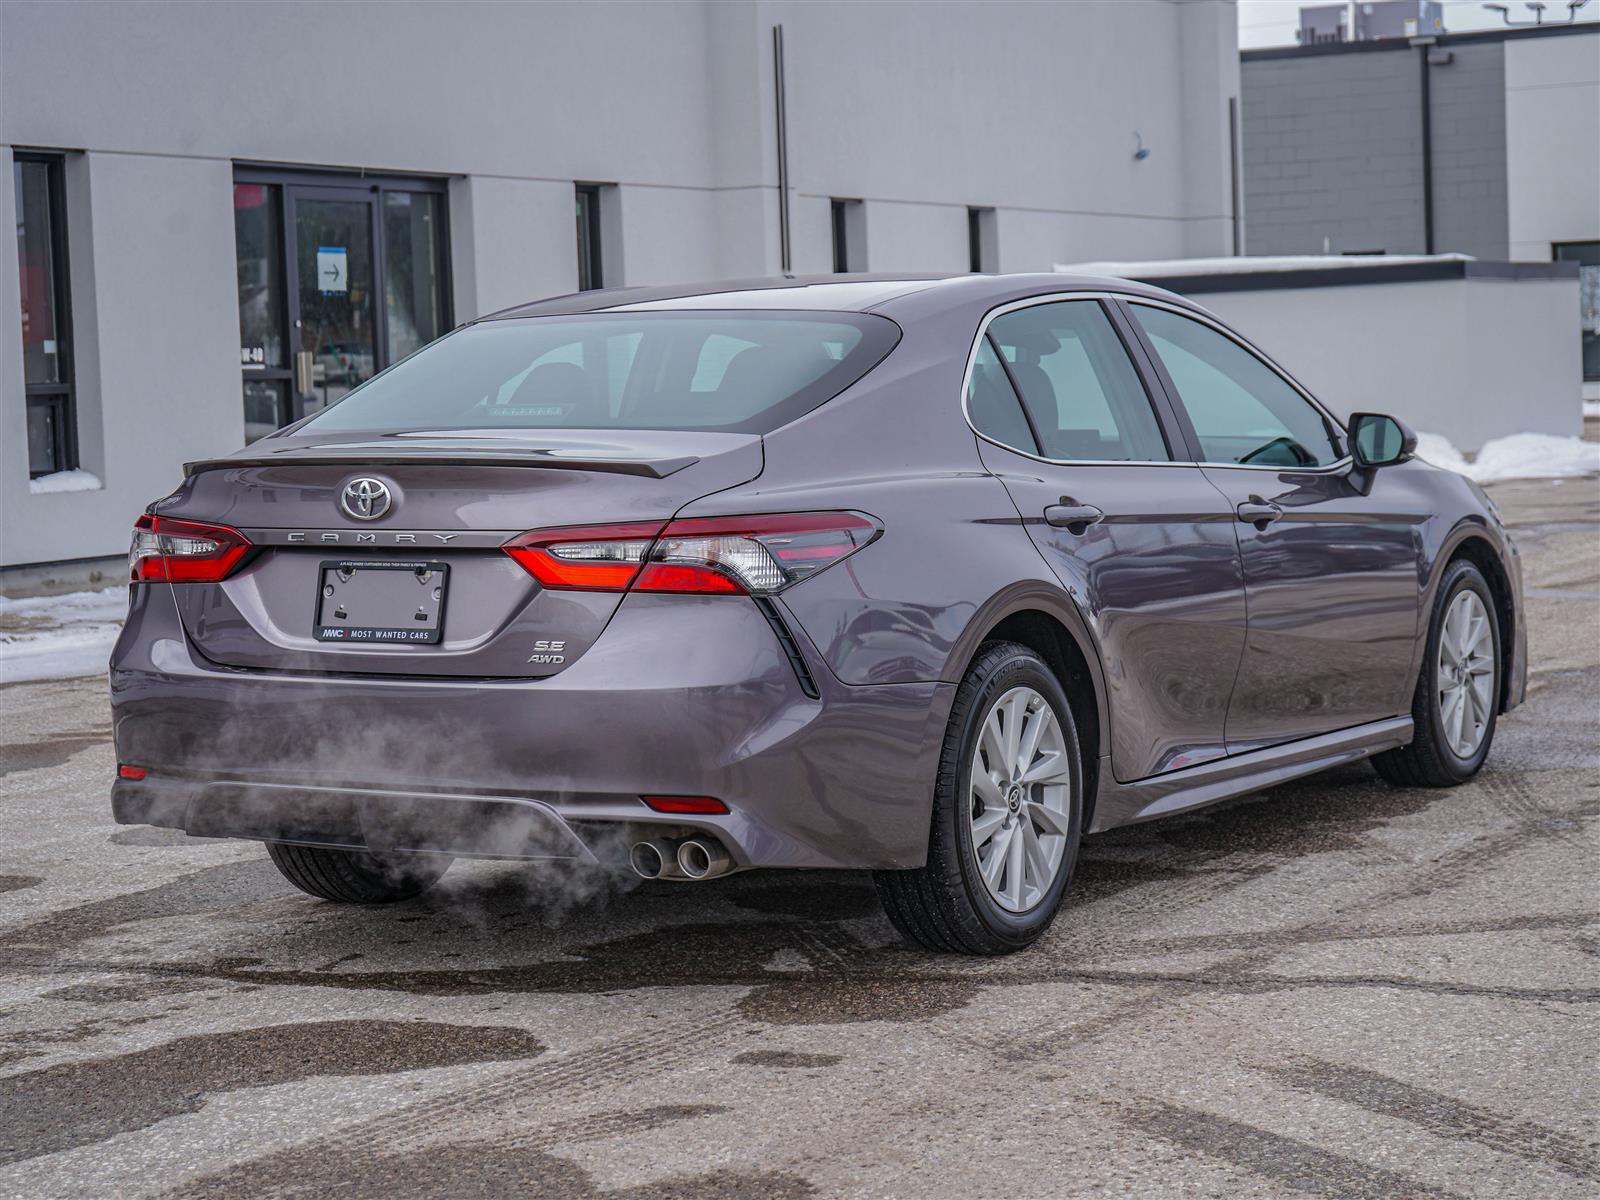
[{"x1": 110, "y1": 587, "x2": 954, "y2": 867}]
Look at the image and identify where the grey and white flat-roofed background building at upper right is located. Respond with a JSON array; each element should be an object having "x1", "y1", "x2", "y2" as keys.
[{"x1": 1240, "y1": 24, "x2": 1600, "y2": 397}]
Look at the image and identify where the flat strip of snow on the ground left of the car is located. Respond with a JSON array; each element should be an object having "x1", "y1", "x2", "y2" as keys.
[{"x1": 0, "y1": 587, "x2": 128, "y2": 683}]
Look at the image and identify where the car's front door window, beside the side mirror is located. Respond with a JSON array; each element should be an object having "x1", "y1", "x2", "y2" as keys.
[{"x1": 1131, "y1": 304, "x2": 1341, "y2": 467}]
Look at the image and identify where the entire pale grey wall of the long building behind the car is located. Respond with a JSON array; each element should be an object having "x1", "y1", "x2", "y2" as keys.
[{"x1": 0, "y1": 0, "x2": 1238, "y2": 566}]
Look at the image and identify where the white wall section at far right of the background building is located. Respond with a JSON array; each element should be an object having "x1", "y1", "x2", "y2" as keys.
[{"x1": 1506, "y1": 35, "x2": 1600, "y2": 262}]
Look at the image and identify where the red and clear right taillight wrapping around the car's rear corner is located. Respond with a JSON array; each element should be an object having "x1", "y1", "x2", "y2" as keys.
[{"x1": 504, "y1": 512, "x2": 878, "y2": 595}]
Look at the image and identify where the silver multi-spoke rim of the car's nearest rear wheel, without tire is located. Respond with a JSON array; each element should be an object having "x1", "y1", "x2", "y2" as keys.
[{"x1": 966, "y1": 686, "x2": 1072, "y2": 912}]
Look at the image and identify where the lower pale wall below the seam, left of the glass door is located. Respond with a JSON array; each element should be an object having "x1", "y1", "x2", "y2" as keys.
[{"x1": 0, "y1": 154, "x2": 245, "y2": 563}]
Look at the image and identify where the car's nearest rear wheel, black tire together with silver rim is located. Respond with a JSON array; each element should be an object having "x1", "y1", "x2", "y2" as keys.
[{"x1": 874, "y1": 642, "x2": 1083, "y2": 954}]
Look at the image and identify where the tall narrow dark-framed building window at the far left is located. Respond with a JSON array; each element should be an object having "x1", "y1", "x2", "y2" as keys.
[{"x1": 11, "y1": 150, "x2": 78, "y2": 477}]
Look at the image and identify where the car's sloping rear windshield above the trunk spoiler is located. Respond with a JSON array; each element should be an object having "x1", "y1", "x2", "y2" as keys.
[{"x1": 299, "y1": 312, "x2": 899, "y2": 434}]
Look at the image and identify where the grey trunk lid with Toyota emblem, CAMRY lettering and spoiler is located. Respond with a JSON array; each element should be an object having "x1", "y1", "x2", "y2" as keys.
[{"x1": 152, "y1": 430, "x2": 762, "y2": 678}]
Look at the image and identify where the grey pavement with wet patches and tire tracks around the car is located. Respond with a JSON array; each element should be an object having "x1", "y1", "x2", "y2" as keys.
[{"x1": 0, "y1": 480, "x2": 1600, "y2": 1200}]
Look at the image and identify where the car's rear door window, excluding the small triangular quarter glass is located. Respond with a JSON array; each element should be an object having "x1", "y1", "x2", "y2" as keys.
[{"x1": 989, "y1": 301, "x2": 1171, "y2": 462}]
